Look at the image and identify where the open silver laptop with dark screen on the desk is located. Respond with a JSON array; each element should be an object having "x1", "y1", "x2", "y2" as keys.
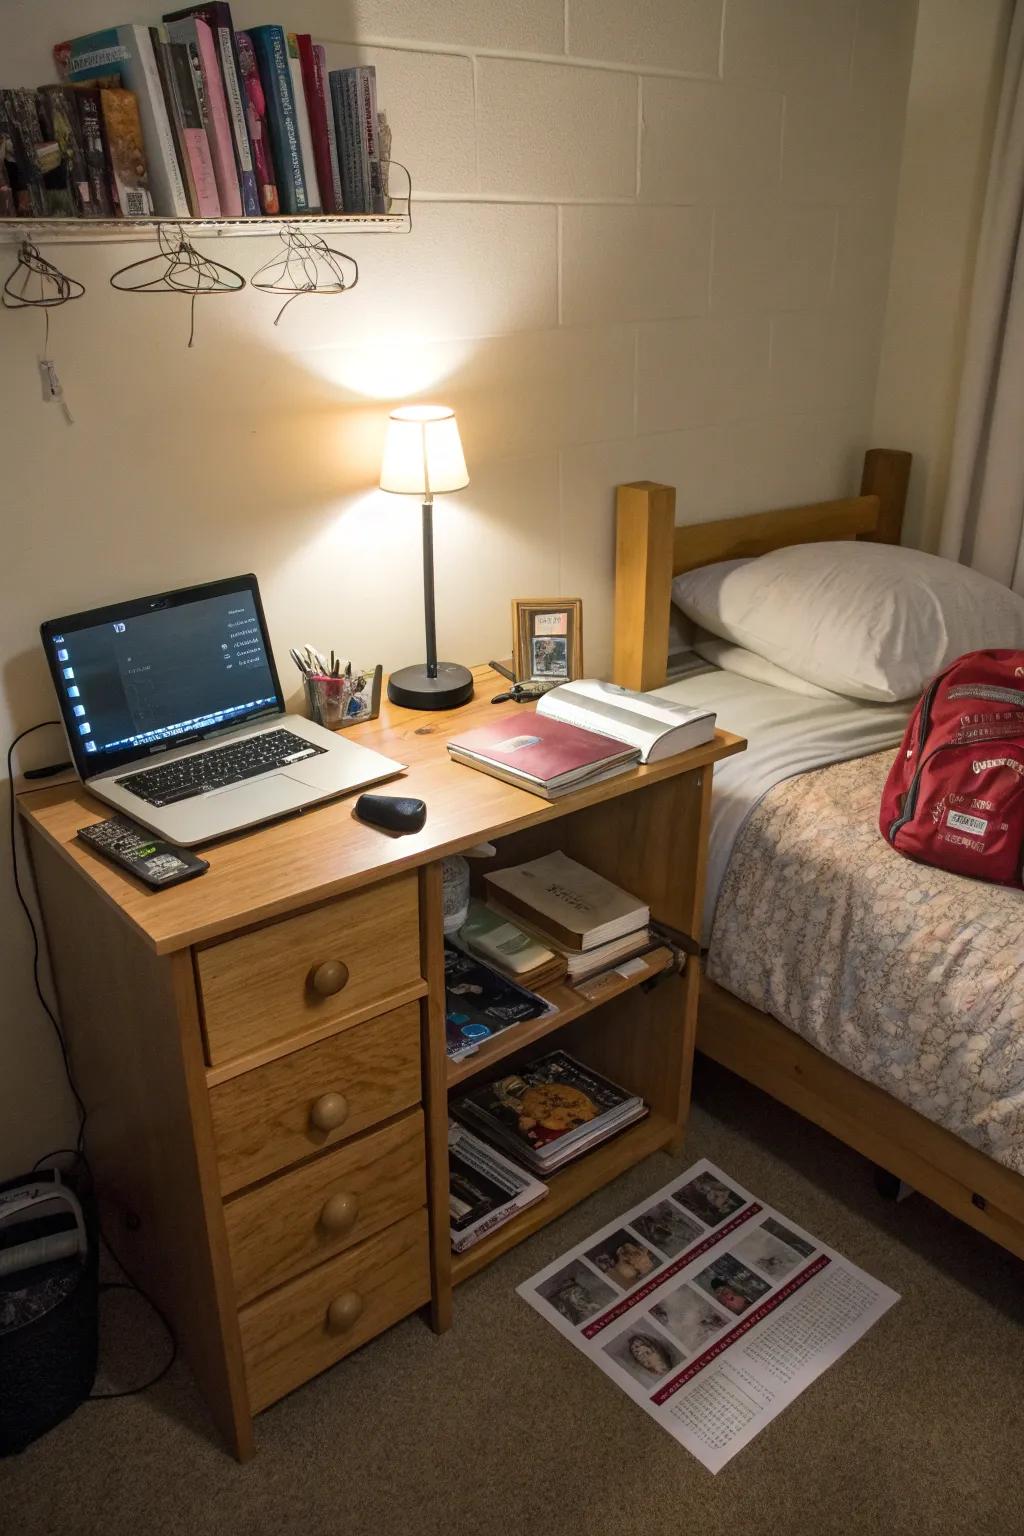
[{"x1": 40, "y1": 576, "x2": 405, "y2": 848}]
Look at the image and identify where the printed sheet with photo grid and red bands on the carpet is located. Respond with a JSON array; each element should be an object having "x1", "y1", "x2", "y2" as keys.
[{"x1": 519, "y1": 1158, "x2": 900, "y2": 1471}]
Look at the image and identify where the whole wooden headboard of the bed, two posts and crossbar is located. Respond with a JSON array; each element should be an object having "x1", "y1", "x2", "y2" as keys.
[{"x1": 611, "y1": 449, "x2": 910, "y2": 690}]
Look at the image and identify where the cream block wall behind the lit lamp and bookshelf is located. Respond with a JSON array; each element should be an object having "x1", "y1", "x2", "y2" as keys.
[{"x1": 0, "y1": 0, "x2": 917, "y2": 1174}]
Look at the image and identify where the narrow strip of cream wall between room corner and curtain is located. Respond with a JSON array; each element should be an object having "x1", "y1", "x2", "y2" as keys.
[{"x1": 874, "y1": 0, "x2": 1012, "y2": 550}]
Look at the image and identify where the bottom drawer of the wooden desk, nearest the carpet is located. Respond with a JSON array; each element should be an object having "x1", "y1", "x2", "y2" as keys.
[{"x1": 238, "y1": 1210, "x2": 430, "y2": 1413}]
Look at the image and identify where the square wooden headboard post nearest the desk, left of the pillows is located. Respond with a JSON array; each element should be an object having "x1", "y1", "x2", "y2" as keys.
[{"x1": 611, "y1": 481, "x2": 676, "y2": 691}]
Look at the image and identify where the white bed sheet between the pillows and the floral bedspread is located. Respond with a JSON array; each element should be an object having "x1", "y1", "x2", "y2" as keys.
[{"x1": 657, "y1": 659, "x2": 913, "y2": 945}]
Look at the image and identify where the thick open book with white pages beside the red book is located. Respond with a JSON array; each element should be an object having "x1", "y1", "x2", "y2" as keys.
[{"x1": 537, "y1": 677, "x2": 715, "y2": 763}]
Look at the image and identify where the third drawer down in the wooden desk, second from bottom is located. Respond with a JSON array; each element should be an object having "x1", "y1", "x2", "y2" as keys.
[{"x1": 224, "y1": 1109, "x2": 427, "y2": 1304}]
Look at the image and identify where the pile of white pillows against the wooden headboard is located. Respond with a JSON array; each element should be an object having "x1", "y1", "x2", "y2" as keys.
[{"x1": 672, "y1": 539, "x2": 1024, "y2": 703}]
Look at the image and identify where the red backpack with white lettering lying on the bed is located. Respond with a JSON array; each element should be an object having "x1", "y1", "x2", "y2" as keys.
[{"x1": 878, "y1": 651, "x2": 1024, "y2": 886}]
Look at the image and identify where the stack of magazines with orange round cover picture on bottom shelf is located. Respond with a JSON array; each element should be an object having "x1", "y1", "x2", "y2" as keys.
[{"x1": 451, "y1": 1051, "x2": 648, "y2": 1175}]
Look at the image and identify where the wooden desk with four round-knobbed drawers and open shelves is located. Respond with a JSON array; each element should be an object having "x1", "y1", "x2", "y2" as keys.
[{"x1": 18, "y1": 667, "x2": 745, "y2": 1459}]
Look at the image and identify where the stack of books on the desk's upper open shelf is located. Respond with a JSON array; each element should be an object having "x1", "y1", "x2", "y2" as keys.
[{"x1": 484, "y1": 852, "x2": 651, "y2": 983}]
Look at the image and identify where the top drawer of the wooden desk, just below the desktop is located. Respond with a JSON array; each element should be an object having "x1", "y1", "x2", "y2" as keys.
[{"x1": 195, "y1": 874, "x2": 419, "y2": 1066}]
